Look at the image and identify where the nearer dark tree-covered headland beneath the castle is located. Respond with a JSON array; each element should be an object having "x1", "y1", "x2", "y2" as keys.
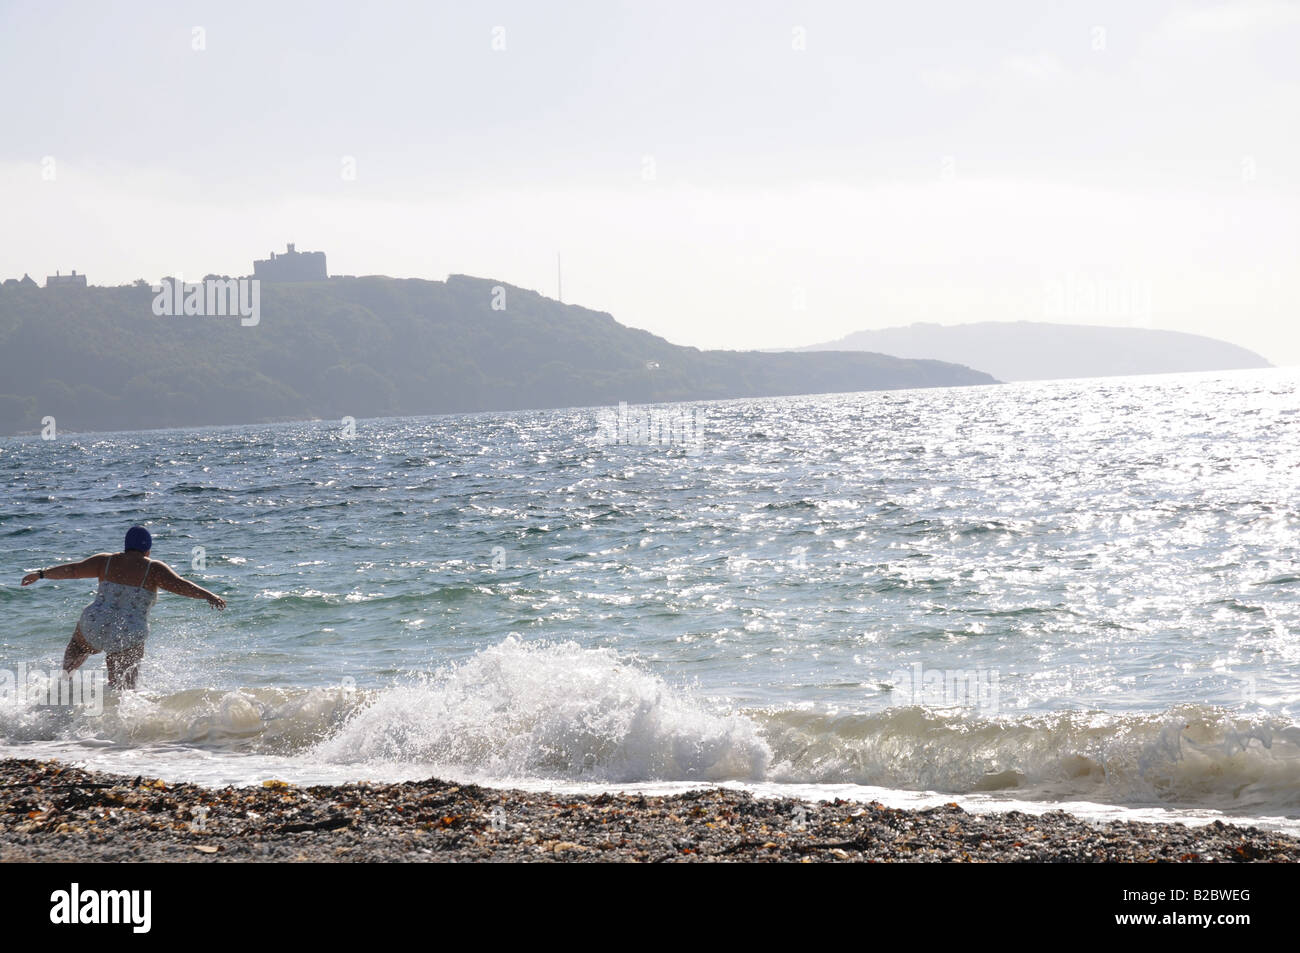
[{"x1": 0, "y1": 276, "x2": 992, "y2": 433}]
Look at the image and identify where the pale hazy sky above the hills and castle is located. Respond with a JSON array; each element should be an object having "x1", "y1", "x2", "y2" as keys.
[{"x1": 0, "y1": 0, "x2": 1300, "y2": 364}]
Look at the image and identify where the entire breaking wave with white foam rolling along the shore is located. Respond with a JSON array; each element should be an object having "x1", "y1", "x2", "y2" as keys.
[{"x1": 0, "y1": 637, "x2": 1300, "y2": 816}]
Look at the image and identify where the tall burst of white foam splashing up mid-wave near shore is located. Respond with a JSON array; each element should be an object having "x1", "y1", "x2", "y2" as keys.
[{"x1": 313, "y1": 638, "x2": 771, "y2": 781}]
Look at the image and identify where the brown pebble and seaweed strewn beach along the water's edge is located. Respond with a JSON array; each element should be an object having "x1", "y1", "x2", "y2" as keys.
[{"x1": 0, "y1": 759, "x2": 1300, "y2": 863}]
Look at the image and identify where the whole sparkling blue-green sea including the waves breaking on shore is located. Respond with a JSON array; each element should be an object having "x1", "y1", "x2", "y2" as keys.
[{"x1": 0, "y1": 369, "x2": 1300, "y2": 831}]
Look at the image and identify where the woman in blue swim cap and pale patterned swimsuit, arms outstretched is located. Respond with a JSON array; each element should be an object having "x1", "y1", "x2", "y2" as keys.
[{"x1": 22, "y1": 527, "x2": 226, "y2": 689}]
